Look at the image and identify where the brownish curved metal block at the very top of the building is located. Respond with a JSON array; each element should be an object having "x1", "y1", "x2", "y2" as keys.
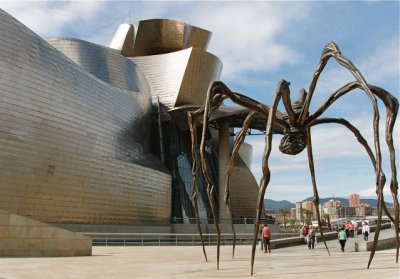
[{"x1": 133, "y1": 19, "x2": 211, "y2": 56}]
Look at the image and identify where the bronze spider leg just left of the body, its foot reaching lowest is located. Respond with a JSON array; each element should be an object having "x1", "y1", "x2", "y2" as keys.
[{"x1": 251, "y1": 80, "x2": 289, "y2": 275}]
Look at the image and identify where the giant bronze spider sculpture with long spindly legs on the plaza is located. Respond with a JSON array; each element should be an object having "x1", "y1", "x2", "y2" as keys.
[{"x1": 188, "y1": 42, "x2": 399, "y2": 275}]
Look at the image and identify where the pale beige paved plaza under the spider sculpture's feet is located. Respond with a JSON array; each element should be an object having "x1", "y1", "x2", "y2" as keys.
[{"x1": 0, "y1": 229, "x2": 400, "y2": 279}]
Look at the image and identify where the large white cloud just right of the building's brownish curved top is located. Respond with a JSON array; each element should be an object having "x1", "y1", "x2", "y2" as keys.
[{"x1": 172, "y1": 1, "x2": 308, "y2": 82}]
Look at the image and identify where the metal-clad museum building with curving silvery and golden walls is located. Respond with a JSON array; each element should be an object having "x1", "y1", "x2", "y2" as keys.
[{"x1": 0, "y1": 10, "x2": 264, "y2": 231}]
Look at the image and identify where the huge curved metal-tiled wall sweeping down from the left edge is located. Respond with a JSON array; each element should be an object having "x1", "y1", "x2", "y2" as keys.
[{"x1": 0, "y1": 10, "x2": 171, "y2": 225}]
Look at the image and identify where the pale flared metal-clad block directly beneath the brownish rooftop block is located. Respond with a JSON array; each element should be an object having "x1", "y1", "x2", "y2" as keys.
[{"x1": 130, "y1": 48, "x2": 222, "y2": 109}]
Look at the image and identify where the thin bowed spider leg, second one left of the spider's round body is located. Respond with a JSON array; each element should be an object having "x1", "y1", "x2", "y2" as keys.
[{"x1": 224, "y1": 111, "x2": 256, "y2": 258}]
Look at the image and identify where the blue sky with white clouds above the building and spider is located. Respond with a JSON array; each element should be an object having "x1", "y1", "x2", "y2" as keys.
[{"x1": 0, "y1": 1, "x2": 400, "y2": 202}]
